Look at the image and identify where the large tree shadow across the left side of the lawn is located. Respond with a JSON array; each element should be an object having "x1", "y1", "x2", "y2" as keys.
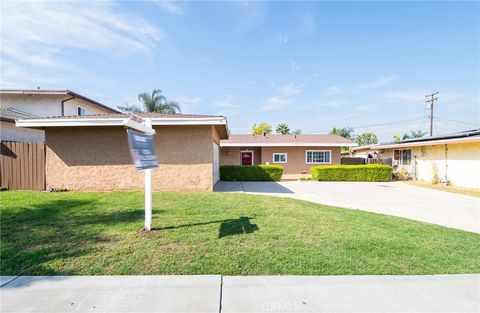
[{"x1": 1, "y1": 199, "x2": 143, "y2": 275}]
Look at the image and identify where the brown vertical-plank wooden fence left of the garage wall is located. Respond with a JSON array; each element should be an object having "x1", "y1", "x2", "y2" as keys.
[{"x1": 0, "y1": 141, "x2": 45, "y2": 190}]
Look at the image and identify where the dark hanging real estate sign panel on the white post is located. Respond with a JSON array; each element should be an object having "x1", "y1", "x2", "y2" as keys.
[{"x1": 127, "y1": 130, "x2": 158, "y2": 170}]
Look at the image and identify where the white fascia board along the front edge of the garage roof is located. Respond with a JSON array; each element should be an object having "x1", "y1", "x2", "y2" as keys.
[{"x1": 15, "y1": 117, "x2": 227, "y2": 127}]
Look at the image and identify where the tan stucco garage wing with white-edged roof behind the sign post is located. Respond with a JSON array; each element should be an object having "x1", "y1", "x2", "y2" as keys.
[{"x1": 16, "y1": 113, "x2": 228, "y2": 191}]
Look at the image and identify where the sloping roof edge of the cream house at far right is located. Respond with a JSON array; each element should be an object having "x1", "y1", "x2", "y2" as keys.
[{"x1": 352, "y1": 129, "x2": 480, "y2": 151}]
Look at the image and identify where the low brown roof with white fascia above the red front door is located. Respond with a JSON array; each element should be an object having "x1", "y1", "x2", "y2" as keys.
[{"x1": 220, "y1": 134, "x2": 356, "y2": 147}]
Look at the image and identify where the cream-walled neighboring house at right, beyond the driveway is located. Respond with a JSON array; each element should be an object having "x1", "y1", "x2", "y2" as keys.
[{"x1": 351, "y1": 129, "x2": 480, "y2": 188}]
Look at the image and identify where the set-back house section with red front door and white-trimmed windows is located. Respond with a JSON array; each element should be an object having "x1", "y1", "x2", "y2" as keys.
[{"x1": 220, "y1": 134, "x2": 356, "y2": 179}]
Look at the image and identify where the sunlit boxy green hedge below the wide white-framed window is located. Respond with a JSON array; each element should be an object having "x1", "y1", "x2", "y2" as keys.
[{"x1": 310, "y1": 164, "x2": 392, "y2": 181}]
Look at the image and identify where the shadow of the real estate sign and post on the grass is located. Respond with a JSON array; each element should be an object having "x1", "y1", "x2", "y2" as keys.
[{"x1": 152, "y1": 216, "x2": 258, "y2": 238}]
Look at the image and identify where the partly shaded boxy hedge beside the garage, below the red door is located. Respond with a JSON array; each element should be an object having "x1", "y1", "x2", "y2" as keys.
[{"x1": 220, "y1": 165, "x2": 283, "y2": 181}]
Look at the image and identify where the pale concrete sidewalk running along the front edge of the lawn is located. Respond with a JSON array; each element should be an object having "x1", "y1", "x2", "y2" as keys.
[{"x1": 0, "y1": 275, "x2": 480, "y2": 313}]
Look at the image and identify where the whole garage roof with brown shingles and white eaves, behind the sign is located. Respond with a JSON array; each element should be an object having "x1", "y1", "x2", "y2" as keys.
[{"x1": 16, "y1": 113, "x2": 228, "y2": 138}]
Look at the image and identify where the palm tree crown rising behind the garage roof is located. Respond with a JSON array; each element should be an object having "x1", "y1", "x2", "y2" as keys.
[{"x1": 118, "y1": 89, "x2": 181, "y2": 114}]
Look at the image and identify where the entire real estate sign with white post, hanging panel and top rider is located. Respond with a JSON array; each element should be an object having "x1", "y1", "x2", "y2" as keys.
[{"x1": 124, "y1": 114, "x2": 158, "y2": 231}]
